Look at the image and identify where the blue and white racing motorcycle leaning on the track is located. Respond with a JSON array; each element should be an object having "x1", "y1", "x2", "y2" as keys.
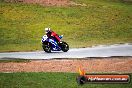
[{"x1": 41, "y1": 35, "x2": 69, "y2": 53}]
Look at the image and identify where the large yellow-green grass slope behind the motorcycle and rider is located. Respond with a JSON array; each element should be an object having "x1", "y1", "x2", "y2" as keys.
[{"x1": 0, "y1": 0, "x2": 132, "y2": 52}]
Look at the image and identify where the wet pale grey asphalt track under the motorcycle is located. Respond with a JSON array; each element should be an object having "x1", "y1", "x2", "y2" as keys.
[{"x1": 0, "y1": 44, "x2": 132, "y2": 59}]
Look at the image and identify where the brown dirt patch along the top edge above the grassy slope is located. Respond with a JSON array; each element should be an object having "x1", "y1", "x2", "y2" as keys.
[{"x1": 4, "y1": 0, "x2": 87, "y2": 6}]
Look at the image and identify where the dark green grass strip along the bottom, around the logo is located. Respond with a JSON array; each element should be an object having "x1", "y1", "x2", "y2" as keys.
[{"x1": 0, "y1": 72, "x2": 132, "y2": 88}]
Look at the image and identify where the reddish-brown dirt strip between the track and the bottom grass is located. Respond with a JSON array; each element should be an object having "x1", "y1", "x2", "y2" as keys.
[{"x1": 0, "y1": 57, "x2": 132, "y2": 73}]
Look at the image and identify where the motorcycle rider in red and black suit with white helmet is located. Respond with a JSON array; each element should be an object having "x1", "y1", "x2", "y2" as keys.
[{"x1": 45, "y1": 28, "x2": 61, "y2": 43}]
